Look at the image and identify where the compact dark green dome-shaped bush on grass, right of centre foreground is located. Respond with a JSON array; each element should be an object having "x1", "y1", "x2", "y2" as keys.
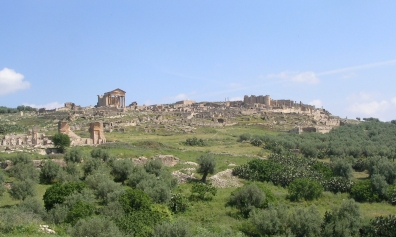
[{"x1": 288, "y1": 178, "x2": 324, "y2": 201}]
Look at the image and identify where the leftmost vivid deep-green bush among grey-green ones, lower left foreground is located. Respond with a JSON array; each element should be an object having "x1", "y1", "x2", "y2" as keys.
[{"x1": 43, "y1": 182, "x2": 87, "y2": 211}]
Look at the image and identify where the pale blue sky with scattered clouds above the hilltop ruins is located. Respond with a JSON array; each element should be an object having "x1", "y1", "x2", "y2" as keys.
[{"x1": 0, "y1": 0, "x2": 396, "y2": 121}]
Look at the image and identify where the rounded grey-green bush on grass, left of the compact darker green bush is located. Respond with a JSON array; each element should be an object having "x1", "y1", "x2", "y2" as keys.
[{"x1": 228, "y1": 184, "x2": 265, "y2": 217}]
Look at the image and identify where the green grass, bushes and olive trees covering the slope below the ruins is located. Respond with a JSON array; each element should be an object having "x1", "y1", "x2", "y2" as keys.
[{"x1": 0, "y1": 114, "x2": 396, "y2": 237}]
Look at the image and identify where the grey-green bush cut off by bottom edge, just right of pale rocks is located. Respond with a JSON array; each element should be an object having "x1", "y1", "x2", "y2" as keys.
[{"x1": 68, "y1": 216, "x2": 124, "y2": 237}]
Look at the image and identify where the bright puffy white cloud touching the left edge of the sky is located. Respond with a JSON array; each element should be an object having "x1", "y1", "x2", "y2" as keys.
[{"x1": 0, "y1": 68, "x2": 30, "y2": 95}]
